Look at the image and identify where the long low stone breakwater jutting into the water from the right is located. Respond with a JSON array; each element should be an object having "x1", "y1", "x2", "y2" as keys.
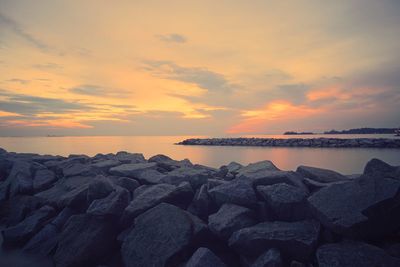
[{"x1": 177, "y1": 137, "x2": 400, "y2": 148}]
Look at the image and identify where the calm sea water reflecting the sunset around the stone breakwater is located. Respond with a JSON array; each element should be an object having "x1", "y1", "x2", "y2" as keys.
[{"x1": 0, "y1": 135, "x2": 400, "y2": 174}]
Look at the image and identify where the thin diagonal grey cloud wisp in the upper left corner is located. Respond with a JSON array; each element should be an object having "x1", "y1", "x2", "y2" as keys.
[{"x1": 0, "y1": 13, "x2": 50, "y2": 52}]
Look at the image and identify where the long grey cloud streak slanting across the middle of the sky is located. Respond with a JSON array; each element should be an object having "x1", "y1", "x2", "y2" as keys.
[{"x1": 144, "y1": 61, "x2": 233, "y2": 92}]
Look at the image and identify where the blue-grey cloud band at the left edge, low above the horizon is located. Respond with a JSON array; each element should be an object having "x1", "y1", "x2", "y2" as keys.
[{"x1": 0, "y1": 90, "x2": 92, "y2": 115}]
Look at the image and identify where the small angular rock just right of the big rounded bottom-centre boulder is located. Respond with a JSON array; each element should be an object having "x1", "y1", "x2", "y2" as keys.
[{"x1": 208, "y1": 204, "x2": 257, "y2": 240}]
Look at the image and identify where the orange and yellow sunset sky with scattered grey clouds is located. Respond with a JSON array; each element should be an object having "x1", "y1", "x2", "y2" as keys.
[{"x1": 0, "y1": 0, "x2": 400, "y2": 136}]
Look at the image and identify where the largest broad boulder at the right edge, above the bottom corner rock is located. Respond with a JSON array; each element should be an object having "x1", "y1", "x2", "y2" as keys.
[{"x1": 308, "y1": 176, "x2": 400, "y2": 238}]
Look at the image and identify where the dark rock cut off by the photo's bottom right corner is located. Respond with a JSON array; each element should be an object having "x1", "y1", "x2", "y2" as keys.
[{"x1": 316, "y1": 242, "x2": 400, "y2": 267}]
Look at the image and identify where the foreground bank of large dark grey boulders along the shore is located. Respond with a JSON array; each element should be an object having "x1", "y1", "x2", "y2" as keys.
[{"x1": 0, "y1": 149, "x2": 400, "y2": 267}]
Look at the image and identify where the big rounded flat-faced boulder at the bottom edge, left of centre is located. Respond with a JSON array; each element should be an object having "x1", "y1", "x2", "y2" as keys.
[{"x1": 121, "y1": 203, "x2": 206, "y2": 267}]
